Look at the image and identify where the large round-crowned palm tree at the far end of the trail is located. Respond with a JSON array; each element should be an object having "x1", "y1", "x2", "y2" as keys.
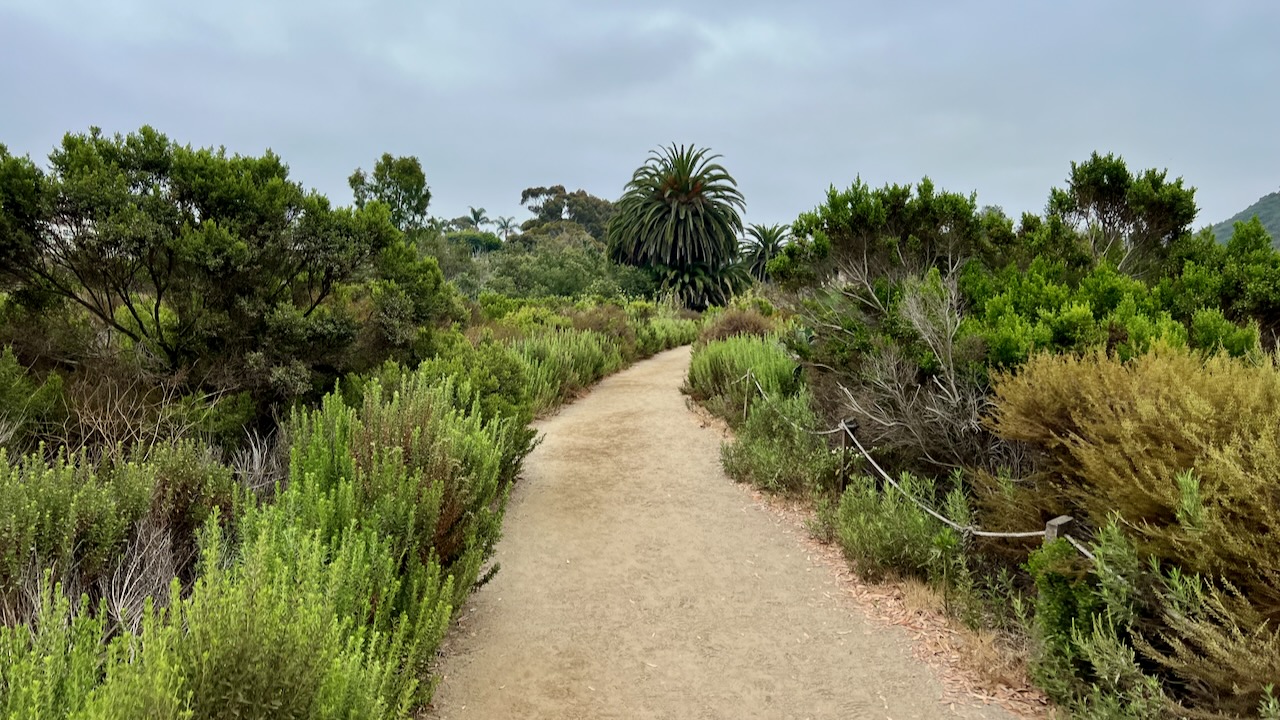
[{"x1": 608, "y1": 145, "x2": 746, "y2": 306}]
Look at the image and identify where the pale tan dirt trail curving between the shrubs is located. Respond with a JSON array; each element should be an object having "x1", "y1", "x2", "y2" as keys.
[{"x1": 429, "y1": 348, "x2": 1011, "y2": 720}]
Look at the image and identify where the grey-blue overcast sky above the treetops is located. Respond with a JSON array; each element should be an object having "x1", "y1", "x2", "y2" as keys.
[{"x1": 0, "y1": 0, "x2": 1280, "y2": 225}]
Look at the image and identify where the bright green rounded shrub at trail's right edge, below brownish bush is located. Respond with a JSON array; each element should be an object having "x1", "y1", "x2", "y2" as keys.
[{"x1": 685, "y1": 336, "x2": 801, "y2": 424}]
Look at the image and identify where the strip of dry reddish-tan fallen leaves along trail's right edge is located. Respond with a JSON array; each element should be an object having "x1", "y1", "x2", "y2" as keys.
[{"x1": 750, "y1": 491, "x2": 1053, "y2": 720}]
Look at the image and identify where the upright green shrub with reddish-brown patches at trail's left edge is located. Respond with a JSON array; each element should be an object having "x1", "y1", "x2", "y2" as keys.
[{"x1": 293, "y1": 374, "x2": 509, "y2": 600}]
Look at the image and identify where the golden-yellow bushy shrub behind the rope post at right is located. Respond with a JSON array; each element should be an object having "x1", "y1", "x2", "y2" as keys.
[{"x1": 989, "y1": 347, "x2": 1280, "y2": 620}]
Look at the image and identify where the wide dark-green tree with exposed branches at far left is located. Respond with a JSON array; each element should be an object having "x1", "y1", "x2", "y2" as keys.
[{"x1": 0, "y1": 128, "x2": 462, "y2": 427}]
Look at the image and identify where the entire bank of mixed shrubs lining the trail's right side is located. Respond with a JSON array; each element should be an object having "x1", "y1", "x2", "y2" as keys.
[{"x1": 690, "y1": 154, "x2": 1280, "y2": 719}]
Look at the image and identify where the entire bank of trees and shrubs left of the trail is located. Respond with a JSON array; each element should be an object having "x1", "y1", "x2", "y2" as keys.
[{"x1": 0, "y1": 128, "x2": 700, "y2": 719}]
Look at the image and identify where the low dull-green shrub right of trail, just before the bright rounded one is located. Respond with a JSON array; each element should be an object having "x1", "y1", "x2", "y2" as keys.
[{"x1": 721, "y1": 392, "x2": 840, "y2": 492}]
